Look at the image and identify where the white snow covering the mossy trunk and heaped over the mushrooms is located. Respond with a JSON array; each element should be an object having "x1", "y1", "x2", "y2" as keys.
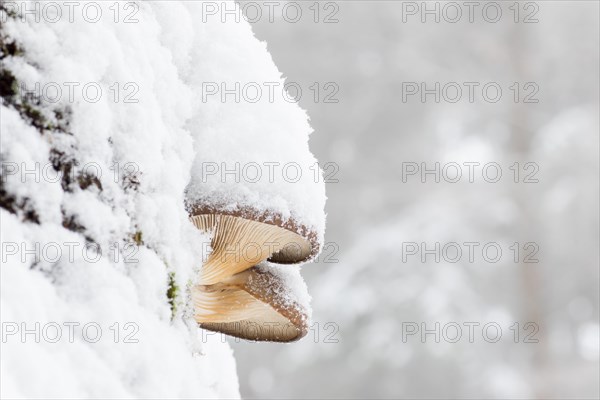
[{"x1": 0, "y1": 1, "x2": 325, "y2": 398}]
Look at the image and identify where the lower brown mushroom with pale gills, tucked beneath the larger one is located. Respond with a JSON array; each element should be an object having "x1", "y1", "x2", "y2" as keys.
[{"x1": 192, "y1": 267, "x2": 309, "y2": 342}]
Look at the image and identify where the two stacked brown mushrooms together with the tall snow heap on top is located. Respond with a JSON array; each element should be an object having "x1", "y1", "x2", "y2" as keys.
[{"x1": 185, "y1": 9, "x2": 327, "y2": 342}]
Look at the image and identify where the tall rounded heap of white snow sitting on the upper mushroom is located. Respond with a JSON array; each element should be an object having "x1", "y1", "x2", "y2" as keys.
[{"x1": 187, "y1": 0, "x2": 326, "y2": 253}]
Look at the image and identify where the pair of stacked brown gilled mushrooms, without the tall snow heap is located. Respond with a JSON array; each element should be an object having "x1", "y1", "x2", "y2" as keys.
[{"x1": 190, "y1": 207, "x2": 319, "y2": 342}]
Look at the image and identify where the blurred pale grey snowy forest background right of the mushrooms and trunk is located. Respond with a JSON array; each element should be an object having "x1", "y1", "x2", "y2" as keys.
[{"x1": 231, "y1": 1, "x2": 600, "y2": 399}]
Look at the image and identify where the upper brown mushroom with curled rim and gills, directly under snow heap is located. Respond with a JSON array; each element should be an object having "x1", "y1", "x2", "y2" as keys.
[{"x1": 190, "y1": 207, "x2": 319, "y2": 285}]
